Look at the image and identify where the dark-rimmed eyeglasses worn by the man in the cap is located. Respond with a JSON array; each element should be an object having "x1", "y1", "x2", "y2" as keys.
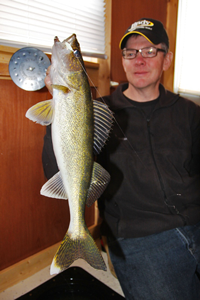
[{"x1": 122, "y1": 47, "x2": 166, "y2": 59}]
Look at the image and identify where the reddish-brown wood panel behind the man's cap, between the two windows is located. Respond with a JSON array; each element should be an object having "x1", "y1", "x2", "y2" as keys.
[{"x1": 111, "y1": 0, "x2": 168, "y2": 83}]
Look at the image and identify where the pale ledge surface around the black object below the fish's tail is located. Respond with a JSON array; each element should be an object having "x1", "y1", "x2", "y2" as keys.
[{"x1": 0, "y1": 252, "x2": 124, "y2": 300}]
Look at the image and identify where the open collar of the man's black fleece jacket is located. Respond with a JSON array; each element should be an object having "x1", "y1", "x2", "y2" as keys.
[{"x1": 109, "y1": 83, "x2": 179, "y2": 111}]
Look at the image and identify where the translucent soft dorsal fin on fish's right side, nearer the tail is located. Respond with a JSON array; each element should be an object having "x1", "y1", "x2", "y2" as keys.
[{"x1": 86, "y1": 162, "x2": 110, "y2": 206}]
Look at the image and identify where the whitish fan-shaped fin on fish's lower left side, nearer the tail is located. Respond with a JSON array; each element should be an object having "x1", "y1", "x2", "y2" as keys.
[{"x1": 40, "y1": 172, "x2": 68, "y2": 200}]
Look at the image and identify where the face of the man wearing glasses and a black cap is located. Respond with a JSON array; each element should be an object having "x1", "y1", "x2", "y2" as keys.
[{"x1": 122, "y1": 35, "x2": 171, "y2": 89}]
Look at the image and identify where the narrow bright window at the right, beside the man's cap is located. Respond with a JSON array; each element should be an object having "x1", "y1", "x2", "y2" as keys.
[{"x1": 174, "y1": 0, "x2": 200, "y2": 96}]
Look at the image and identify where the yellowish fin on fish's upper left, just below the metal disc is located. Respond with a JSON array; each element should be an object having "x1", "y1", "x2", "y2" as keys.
[{"x1": 26, "y1": 100, "x2": 54, "y2": 126}]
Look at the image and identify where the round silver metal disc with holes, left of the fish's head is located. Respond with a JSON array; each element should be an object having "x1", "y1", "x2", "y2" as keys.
[{"x1": 9, "y1": 47, "x2": 50, "y2": 91}]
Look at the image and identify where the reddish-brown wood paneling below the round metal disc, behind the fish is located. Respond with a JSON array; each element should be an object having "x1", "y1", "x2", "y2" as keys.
[{"x1": 0, "y1": 80, "x2": 94, "y2": 270}]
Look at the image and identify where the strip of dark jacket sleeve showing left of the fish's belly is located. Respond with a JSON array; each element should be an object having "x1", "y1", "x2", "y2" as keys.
[{"x1": 42, "y1": 125, "x2": 58, "y2": 179}]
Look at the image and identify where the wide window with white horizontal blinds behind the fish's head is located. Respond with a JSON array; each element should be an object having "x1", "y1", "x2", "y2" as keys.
[{"x1": 0, "y1": 0, "x2": 105, "y2": 57}]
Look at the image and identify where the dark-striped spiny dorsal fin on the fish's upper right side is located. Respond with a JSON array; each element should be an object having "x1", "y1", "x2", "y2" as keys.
[{"x1": 93, "y1": 100, "x2": 113, "y2": 155}]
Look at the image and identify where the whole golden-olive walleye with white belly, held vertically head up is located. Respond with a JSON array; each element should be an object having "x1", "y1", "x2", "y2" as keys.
[{"x1": 26, "y1": 34, "x2": 113, "y2": 275}]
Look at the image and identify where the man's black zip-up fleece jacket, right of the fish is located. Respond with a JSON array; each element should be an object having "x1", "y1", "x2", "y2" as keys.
[{"x1": 98, "y1": 84, "x2": 200, "y2": 238}]
